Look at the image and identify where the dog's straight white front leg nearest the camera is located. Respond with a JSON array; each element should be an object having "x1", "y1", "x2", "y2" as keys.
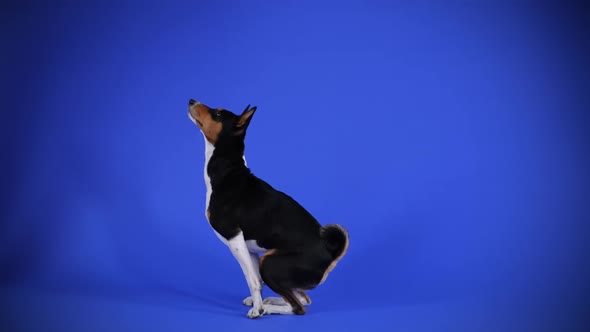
[{"x1": 228, "y1": 231, "x2": 264, "y2": 318}]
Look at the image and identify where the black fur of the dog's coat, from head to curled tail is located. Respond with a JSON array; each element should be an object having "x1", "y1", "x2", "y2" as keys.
[{"x1": 197, "y1": 101, "x2": 348, "y2": 314}]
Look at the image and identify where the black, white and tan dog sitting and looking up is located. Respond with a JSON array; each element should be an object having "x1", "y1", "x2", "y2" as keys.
[{"x1": 188, "y1": 99, "x2": 349, "y2": 318}]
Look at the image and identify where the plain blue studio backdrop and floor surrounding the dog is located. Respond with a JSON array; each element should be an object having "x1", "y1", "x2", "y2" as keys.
[{"x1": 0, "y1": 1, "x2": 590, "y2": 331}]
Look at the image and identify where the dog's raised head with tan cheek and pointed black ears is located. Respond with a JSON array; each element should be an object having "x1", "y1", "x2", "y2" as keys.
[{"x1": 188, "y1": 99, "x2": 256, "y2": 145}]
